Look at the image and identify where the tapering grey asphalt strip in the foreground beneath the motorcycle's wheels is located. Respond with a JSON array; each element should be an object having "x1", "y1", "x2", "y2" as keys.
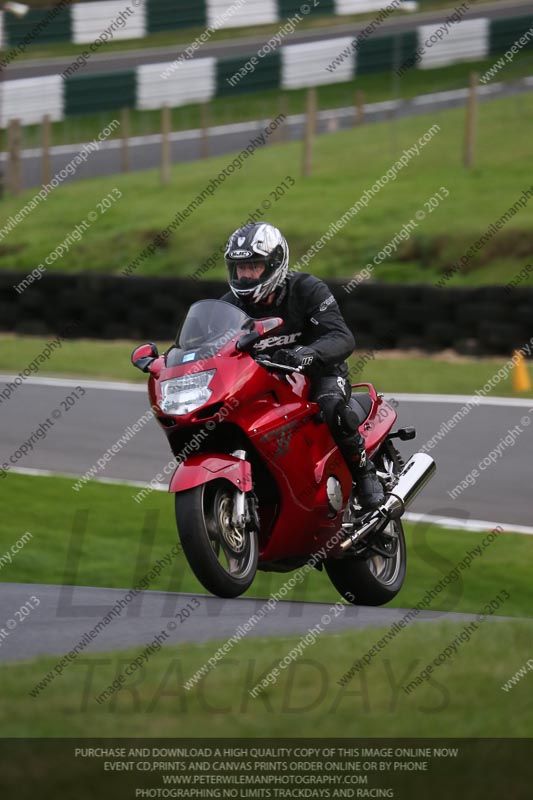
[{"x1": 0, "y1": 583, "x2": 505, "y2": 663}]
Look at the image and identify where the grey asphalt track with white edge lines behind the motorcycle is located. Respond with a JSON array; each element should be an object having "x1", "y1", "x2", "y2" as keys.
[{"x1": 0, "y1": 376, "x2": 533, "y2": 525}]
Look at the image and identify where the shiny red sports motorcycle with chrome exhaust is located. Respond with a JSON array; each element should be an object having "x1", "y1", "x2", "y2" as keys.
[{"x1": 132, "y1": 300, "x2": 435, "y2": 605}]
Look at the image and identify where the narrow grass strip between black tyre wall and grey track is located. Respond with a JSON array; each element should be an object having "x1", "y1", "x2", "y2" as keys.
[{"x1": 0, "y1": 334, "x2": 533, "y2": 397}]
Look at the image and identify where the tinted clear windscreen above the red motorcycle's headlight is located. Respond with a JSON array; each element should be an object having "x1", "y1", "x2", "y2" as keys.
[{"x1": 167, "y1": 300, "x2": 254, "y2": 367}]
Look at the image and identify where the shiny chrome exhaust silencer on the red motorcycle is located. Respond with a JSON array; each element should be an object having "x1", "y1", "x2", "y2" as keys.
[{"x1": 340, "y1": 453, "x2": 437, "y2": 550}]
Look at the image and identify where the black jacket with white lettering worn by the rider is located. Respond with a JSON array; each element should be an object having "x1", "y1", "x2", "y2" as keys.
[{"x1": 221, "y1": 272, "x2": 355, "y2": 378}]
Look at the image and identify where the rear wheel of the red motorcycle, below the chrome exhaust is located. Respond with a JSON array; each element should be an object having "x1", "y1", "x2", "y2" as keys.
[{"x1": 325, "y1": 520, "x2": 407, "y2": 606}]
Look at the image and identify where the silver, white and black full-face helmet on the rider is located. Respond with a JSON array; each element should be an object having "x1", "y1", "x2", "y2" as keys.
[{"x1": 224, "y1": 222, "x2": 289, "y2": 303}]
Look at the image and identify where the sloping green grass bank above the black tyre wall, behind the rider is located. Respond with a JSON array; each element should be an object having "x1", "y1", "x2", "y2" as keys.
[{"x1": 0, "y1": 95, "x2": 533, "y2": 292}]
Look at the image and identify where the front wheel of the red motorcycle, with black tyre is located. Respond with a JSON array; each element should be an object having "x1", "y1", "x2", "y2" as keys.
[{"x1": 176, "y1": 480, "x2": 259, "y2": 597}]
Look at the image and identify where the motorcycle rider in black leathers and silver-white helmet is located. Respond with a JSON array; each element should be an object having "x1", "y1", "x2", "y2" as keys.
[{"x1": 221, "y1": 222, "x2": 385, "y2": 510}]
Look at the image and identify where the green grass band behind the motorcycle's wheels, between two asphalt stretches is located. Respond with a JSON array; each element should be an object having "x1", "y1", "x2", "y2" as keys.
[{"x1": 0, "y1": 474, "x2": 533, "y2": 617}]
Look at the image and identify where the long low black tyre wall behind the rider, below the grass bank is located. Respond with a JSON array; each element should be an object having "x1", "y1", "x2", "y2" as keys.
[{"x1": 0, "y1": 272, "x2": 533, "y2": 355}]
